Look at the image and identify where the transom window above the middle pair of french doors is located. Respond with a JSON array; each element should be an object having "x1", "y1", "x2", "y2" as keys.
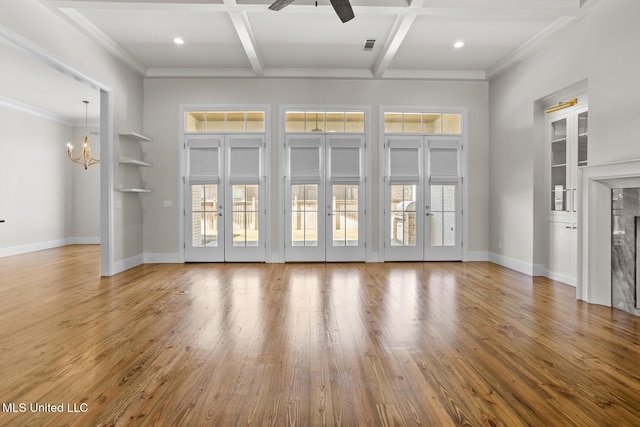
[{"x1": 285, "y1": 111, "x2": 364, "y2": 133}]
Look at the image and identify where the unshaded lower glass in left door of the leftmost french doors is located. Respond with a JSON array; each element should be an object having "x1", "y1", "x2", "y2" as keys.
[{"x1": 191, "y1": 185, "x2": 218, "y2": 247}]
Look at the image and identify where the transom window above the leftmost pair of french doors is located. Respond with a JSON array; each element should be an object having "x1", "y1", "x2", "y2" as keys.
[{"x1": 184, "y1": 111, "x2": 265, "y2": 133}]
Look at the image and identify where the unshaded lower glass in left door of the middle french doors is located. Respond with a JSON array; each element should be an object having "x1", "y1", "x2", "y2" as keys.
[{"x1": 291, "y1": 184, "x2": 318, "y2": 246}]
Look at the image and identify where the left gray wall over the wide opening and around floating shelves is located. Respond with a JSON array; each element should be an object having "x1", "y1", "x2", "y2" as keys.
[{"x1": 0, "y1": 0, "x2": 143, "y2": 265}]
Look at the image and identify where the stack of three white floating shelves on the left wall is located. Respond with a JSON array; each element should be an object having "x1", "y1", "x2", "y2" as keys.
[{"x1": 118, "y1": 132, "x2": 152, "y2": 193}]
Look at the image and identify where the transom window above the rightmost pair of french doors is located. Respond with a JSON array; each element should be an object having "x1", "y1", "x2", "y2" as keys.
[{"x1": 384, "y1": 112, "x2": 462, "y2": 135}]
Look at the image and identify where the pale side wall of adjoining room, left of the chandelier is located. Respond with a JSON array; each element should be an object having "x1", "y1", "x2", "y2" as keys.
[{"x1": 0, "y1": 106, "x2": 73, "y2": 256}]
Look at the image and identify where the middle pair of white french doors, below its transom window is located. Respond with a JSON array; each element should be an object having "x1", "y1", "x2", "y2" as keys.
[{"x1": 285, "y1": 134, "x2": 365, "y2": 261}]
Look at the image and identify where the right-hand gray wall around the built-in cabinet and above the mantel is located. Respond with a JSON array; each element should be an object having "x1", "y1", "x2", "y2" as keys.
[{"x1": 489, "y1": 0, "x2": 640, "y2": 273}]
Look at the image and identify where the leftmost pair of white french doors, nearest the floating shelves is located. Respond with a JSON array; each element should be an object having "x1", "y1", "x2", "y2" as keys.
[{"x1": 184, "y1": 134, "x2": 266, "y2": 262}]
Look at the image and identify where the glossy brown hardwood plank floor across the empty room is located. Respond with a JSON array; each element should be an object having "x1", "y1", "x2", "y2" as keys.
[{"x1": 0, "y1": 246, "x2": 640, "y2": 426}]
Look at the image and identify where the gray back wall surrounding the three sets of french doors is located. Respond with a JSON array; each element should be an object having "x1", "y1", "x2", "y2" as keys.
[{"x1": 143, "y1": 79, "x2": 489, "y2": 259}]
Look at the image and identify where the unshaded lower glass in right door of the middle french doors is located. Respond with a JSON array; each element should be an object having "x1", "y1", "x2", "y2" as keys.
[{"x1": 331, "y1": 185, "x2": 359, "y2": 246}]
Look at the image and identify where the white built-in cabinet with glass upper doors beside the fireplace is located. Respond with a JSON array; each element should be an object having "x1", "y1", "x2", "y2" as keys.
[{"x1": 546, "y1": 105, "x2": 589, "y2": 285}]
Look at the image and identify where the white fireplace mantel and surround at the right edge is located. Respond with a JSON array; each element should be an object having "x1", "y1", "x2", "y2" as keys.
[{"x1": 576, "y1": 160, "x2": 640, "y2": 306}]
